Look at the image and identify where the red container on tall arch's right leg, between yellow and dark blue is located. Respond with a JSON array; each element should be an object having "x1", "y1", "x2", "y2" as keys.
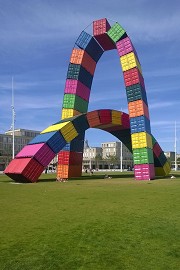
[{"x1": 123, "y1": 67, "x2": 145, "y2": 88}]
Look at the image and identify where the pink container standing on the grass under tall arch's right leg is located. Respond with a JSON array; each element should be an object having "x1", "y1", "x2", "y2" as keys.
[{"x1": 134, "y1": 164, "x2": 155, "y2": 180}]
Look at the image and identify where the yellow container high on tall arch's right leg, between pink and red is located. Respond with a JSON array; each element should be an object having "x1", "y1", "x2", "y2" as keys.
[{"x1": 120, "y1": 52, "x2": 142, "y2": 73}]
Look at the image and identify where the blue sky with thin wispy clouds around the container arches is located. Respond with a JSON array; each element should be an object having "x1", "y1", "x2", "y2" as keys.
[{"x1": 0, "y1": 0, "x2": 180, "y2": 153}]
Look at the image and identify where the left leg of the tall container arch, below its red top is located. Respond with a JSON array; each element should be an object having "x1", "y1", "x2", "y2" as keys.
[{"x1": 57, "y1": 26, "x2": 104, "y2": 178}]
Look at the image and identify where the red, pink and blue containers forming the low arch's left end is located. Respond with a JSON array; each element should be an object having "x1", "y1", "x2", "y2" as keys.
[{"x1": 4, "y1": 131, "x2": 66, "y2": 182}]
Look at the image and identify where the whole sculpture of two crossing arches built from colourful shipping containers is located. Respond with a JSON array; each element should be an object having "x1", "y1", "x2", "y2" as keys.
[{"x1": 5, "y1": 19, "x2": 170, "y2": 182}]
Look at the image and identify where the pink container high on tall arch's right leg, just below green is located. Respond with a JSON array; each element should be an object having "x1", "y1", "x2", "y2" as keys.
[{"x1": 116, "y1": 37, "x2": 140, "y2": 63}]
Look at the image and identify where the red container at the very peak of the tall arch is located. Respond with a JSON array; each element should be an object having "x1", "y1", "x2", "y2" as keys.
[{"x1": 93, "y1": 19, "x2": 116, "y2": 51}]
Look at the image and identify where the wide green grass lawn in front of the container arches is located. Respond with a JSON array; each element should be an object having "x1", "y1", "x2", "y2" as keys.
[{"x1": 0, "y1": 172, "x2": 180, "y2": 270}]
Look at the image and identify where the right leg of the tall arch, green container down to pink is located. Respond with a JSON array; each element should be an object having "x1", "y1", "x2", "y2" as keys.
[{"x1": 102, "y1": 20, "x2": 155, "y2": 180}]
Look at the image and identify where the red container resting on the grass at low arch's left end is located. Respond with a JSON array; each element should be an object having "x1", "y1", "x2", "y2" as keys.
[{"x1": 4, "y1": 158, "x2": 44, "y2": 182}]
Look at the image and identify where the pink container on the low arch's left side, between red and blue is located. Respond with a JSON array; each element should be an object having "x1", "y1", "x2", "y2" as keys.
[{"x1": 16, "y1": 143, "x2": 55, "y2": 167}]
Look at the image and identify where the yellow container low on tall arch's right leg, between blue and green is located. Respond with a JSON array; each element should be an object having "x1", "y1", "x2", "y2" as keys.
[{"x1": 131, "y1": 132, "x2": 153, "y2": 149}]
